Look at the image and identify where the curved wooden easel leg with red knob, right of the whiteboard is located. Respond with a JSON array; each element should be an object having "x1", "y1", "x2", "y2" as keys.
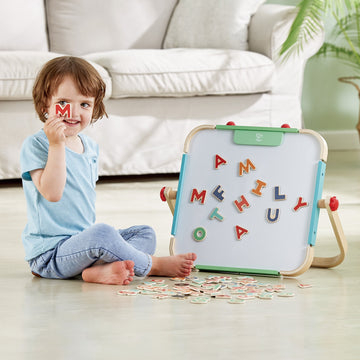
[{"x1": 311, "y1": 197, "x2": 347, "y2": 268}]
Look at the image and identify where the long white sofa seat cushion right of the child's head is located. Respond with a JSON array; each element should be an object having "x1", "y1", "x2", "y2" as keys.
[{"x1": 85, "y1": 49, "x2": 274, "y2": 98}]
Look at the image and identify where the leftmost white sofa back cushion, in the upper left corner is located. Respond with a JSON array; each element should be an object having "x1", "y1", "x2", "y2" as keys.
[{"x1": 0, "y1": 0, "x2": 48, "y2": 51}]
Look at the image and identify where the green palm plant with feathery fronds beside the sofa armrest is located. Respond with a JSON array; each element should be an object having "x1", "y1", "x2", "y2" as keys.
[{"x1": 280, "y1": 0, "x2": 360, "y2": 137}]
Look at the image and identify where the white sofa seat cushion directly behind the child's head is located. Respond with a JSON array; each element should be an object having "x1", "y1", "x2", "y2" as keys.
[{"x1": 0, "y1": 51, "x2": 111, "y2": 100}]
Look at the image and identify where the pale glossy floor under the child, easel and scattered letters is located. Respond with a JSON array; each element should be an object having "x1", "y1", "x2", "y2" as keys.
[{"x1": 0, "y1": 151, "x2": 360, "y2": 360}]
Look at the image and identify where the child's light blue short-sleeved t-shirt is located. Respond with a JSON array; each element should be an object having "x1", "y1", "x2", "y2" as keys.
[{"x1": 20, "y1": 130, "x2": 99, "y2": 260}]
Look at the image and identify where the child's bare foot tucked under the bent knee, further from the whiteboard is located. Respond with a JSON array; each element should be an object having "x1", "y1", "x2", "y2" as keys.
[{"x1": 82, "y1": 260, "x2": 134, "y2": 285}]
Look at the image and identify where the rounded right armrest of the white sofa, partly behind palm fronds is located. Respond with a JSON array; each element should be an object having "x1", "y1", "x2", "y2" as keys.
[{"x1": 248, "y1": 4, "x2": 324, "y2": 61}]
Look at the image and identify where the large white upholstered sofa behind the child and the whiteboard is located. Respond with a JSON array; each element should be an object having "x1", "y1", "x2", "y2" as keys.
[{"x1": 0, "y1": 0, "x2": 323, "y2": 179}]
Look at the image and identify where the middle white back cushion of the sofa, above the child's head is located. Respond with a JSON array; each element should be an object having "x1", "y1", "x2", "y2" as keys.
[{"x1": 46, "y1": 0, "x2": 176, "y2": 55}]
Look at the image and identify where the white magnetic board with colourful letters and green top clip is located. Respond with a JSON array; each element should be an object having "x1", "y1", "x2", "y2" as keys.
[{"x1": 172, "y1": 126, "x2": 326, "y2": 271}]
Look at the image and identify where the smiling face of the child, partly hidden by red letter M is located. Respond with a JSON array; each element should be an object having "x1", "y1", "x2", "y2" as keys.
[{"x1": 47, "y1": 76, "x2": 95, "y2": 137}]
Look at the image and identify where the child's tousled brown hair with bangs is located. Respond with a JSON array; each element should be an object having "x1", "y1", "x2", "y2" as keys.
[{"x1": 32, "y1": 56, "x2": 107, "y2": 123}]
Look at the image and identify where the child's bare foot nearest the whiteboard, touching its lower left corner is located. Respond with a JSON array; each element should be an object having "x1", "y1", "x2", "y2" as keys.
[{"x1": 148, "y1": 253, "x2": 196, "y2": 277}]
